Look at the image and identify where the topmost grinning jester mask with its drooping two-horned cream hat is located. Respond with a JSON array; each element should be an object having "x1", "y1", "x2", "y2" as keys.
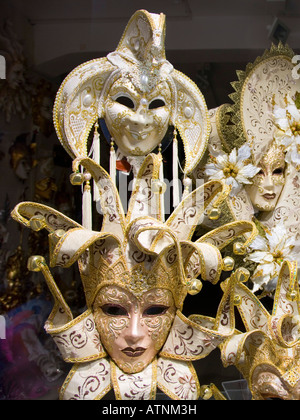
[{"x1": 54, "y1": 10, "x2": 210, "y2": 174}]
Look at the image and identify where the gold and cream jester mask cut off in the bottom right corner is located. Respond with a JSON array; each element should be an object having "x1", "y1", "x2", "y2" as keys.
[{"x1": 221, "y1": 261, "x2": 300, "y2": 400}]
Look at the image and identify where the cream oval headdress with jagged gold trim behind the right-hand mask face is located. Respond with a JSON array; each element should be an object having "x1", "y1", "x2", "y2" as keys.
[{"x1": 230, "y1": 43, "x2": 294, "y2": 162}]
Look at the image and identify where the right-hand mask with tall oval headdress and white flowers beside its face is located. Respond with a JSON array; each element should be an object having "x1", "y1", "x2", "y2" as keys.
[{"x1": 197, "y1": 43, "x2": 300, "y2": 228}]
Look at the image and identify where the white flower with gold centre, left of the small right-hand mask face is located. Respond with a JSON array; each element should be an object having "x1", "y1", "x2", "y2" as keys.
[{"x1": 205, "y1": 144, "x2": 260, "y2": 195}]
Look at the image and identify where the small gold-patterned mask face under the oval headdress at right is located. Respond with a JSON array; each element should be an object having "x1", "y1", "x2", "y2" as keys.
[{"x1": 245, "y1": 146, "x2": 285, "y2": 211}]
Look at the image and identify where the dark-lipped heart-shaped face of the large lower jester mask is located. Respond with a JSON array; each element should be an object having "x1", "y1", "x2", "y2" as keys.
[{"x1": 93, "y1": 286, "x2": 176, "y2": 373}]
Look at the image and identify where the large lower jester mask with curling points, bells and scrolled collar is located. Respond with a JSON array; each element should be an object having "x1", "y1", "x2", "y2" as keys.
[{"x1": 12, "y1": 154, "x2": 257, "y2": 399}]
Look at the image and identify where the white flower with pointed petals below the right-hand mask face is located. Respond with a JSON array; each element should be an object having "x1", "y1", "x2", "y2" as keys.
[{"x1": 245, "y1": 223, "x2": 300, "y2": 293}]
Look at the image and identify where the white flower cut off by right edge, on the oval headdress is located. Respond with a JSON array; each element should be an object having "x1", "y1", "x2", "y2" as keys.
[{"x1": 273, "y1": 98, "x2": 300, "y2": 167}]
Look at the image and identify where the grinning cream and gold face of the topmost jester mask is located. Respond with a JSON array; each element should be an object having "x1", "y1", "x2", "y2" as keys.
[{"x1": 105, "y1": 78, "x2": 171, "y2": 156}]
